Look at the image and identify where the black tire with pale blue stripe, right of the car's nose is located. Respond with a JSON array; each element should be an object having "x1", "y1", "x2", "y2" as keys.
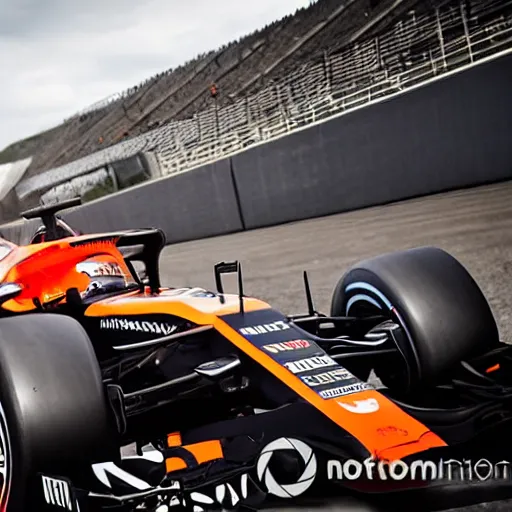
[{"x1": 331, "y1": 247, "x2": 499, "y2": 391}]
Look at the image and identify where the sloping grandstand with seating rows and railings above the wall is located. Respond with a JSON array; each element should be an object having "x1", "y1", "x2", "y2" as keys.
[{"x1": 0, "y1": 0, "x2": 512, "y2": 218}]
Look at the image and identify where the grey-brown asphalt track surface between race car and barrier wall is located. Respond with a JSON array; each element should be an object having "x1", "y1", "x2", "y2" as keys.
[{"x1": 156, "y1": 182, "x2": 512, "y2": 512}]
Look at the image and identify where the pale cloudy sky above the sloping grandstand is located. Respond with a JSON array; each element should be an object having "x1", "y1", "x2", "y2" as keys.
[{"x1": 0, "y1": 0, "x2": 310, "y2": 150}]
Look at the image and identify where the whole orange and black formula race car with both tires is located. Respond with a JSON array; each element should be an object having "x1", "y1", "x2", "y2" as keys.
[{"x1": 0, "y1": 201, "x2": 512, "y2": 512}]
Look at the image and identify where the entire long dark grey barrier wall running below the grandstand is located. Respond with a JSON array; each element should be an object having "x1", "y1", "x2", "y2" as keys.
[{"x1": 0, "y1": 55, "x2": 512, "y2": 243}]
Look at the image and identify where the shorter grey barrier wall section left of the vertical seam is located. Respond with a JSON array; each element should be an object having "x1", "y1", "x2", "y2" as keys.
[{"x1": 62, "y1": 159, "x2": 242, "y2": 243}]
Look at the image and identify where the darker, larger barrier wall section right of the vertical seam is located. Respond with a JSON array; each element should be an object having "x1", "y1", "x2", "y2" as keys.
[{"x1": 233, "y1": 51, "x2": 512, "y2": 228}]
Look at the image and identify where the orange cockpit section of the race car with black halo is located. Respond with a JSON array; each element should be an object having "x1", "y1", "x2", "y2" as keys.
[{"x1": 0, "y1": 198, "x2": 165, "y2": 312}]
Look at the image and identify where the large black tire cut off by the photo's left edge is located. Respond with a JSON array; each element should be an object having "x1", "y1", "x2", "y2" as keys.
[{"x1": 0, "y1": 314, "x2": 113, "y2": 512}]
